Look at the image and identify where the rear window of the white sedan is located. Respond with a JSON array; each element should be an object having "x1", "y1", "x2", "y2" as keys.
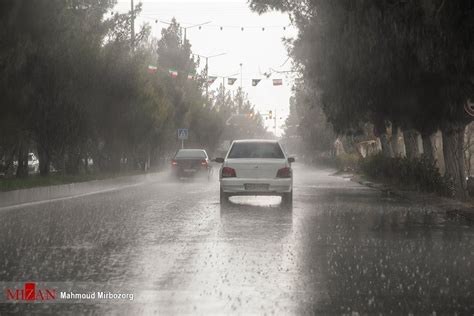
[{"x1": 228, "y1": 142, "x2": 285, "y2": 159}]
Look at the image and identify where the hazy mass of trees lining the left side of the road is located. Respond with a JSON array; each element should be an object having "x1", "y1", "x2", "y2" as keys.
[{"x1": 0, "y1": 0, "x2": 264, "y2": 177}]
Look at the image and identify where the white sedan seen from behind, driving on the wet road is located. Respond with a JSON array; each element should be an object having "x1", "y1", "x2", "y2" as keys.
[{"x1": 215, "y1": 139, "x2": 295, "y2": 204}]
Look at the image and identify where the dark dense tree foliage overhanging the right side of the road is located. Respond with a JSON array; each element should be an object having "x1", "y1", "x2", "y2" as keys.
[{"x1": 250, "y1": 0, "x2": 474, "y2": 197}]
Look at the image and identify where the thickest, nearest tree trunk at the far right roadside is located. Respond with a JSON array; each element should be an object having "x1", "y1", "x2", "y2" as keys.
[{"x1": 442, "y1": 123, "x2": 467, "y2": 200}]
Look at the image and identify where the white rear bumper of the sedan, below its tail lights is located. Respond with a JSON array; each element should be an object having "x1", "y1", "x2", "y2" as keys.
[{"x1": 220, "y1": 178, "x2": 293, "y2": 195}]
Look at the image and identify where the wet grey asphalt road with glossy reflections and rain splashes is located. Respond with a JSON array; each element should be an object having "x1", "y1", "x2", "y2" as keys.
[{"x1": 0, "y1": 165, "x2": 474, "y2": 315}]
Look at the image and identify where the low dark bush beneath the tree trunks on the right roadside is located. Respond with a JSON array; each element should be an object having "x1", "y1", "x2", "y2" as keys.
[{"x1": 360, "y1": 154, "x2": 450, "y2": 196}]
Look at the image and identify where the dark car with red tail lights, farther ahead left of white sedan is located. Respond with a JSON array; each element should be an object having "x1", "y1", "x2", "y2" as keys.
[{"x1": 171, "y1": 149, "x2": 212, "y2": 180}]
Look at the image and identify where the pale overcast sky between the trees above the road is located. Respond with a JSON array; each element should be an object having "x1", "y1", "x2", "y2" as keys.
[{"x1": 114, "y1": 0, "x2": 296, "y2": 134}]
